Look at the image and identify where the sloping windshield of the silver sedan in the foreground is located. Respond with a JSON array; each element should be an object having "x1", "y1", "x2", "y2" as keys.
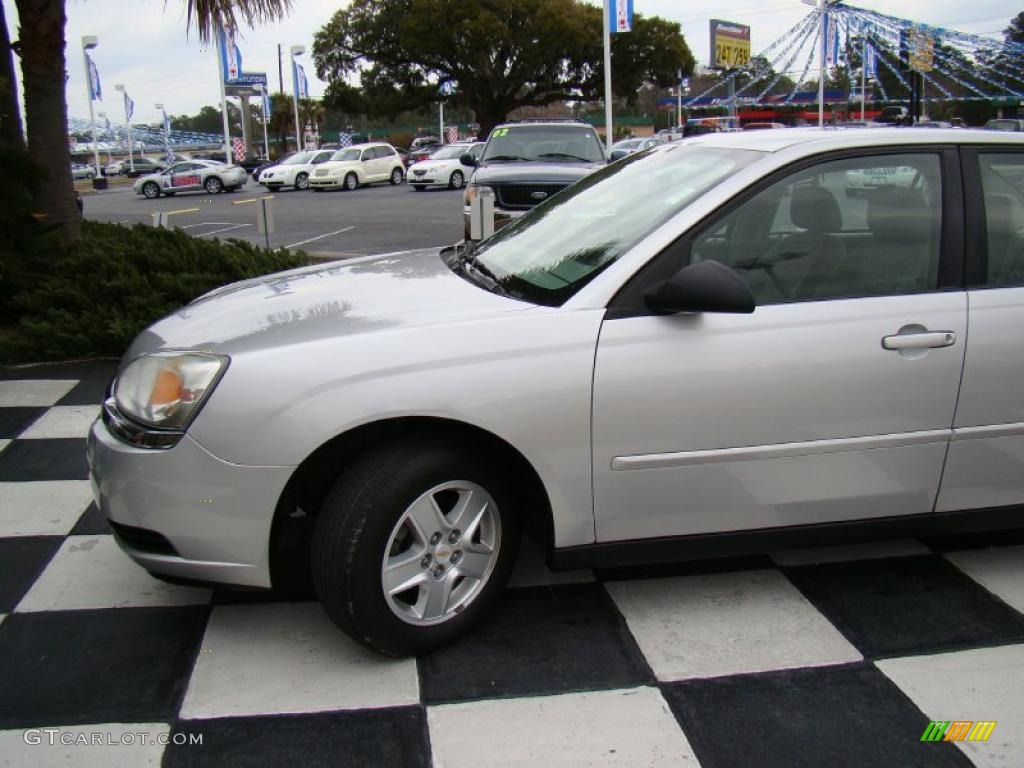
[{"x1": 473, "y1": 144, "x2": 764, "y2": 306}]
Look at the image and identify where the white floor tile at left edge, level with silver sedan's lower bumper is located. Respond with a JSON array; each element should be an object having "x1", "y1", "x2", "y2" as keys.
[{"x1": 0, "y1": 480, "x2": 92, "y2": 537}]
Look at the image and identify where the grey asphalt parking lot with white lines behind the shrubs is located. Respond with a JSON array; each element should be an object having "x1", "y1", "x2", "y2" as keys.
[{"x1": 83, "y1": 179, "x2": 463, "y2": 257}]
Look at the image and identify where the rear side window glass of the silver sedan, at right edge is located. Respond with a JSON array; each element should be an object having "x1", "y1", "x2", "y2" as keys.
[{"x1": 978, "y1": 153, "x2": 1024, "y2": 286}]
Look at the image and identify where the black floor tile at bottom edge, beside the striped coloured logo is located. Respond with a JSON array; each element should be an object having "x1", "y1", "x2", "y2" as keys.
[{"x1": 662, "y1": 664, "x2": 973, "y2": 768}]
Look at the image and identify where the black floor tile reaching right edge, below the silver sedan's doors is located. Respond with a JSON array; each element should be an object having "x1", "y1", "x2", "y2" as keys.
[{"x1": 783, "y1": 555, "x2": 1024, "y2": 658}]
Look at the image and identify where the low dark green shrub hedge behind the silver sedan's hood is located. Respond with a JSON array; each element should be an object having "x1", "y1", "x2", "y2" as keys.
[{"x1": 0, "y1": 221, "x2": 307, "y2": 362}]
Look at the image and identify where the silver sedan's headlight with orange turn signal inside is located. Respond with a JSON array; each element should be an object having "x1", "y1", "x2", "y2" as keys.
[{"x1": 114, "y1": 352, "x2": 228, "y2": 431}]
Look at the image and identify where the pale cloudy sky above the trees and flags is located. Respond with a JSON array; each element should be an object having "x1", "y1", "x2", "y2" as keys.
[{"x1": 2, "y1": 0, "x2": 1021, "y2": 122}]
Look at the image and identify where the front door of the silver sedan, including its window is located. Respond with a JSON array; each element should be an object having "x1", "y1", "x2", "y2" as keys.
[{"x1": 593, "y1": 147, "x2": 967, "y2": 542}]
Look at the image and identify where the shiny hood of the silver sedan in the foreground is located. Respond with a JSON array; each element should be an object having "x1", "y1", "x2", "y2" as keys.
[{"x1": 124, "y1": 248, "x2": 534, "y2": 361}]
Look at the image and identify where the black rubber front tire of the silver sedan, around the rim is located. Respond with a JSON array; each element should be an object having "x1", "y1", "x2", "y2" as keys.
[{"x1": 311, "y1": 436, "x2": 521, "y2": 656}]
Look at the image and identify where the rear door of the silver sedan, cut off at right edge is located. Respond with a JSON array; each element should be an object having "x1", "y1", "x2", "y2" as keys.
[{"x1": 936, "y1": 145, "x2": 1024, "y2": 512}]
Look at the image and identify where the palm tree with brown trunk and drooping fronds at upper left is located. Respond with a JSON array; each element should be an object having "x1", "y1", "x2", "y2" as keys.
[{"x1": 6, "y1": 0, "x2": 292, "y2": 243}]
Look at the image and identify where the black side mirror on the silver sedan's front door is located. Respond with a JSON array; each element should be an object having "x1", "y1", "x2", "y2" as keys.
[{"x1": 644, "y1": 261, "x2": 754, "y2": 314}]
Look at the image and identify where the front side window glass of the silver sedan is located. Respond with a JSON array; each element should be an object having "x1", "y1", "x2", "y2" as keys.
[{"x1": 690, "y1": 153, "x2": 942, "y2": 304}]
